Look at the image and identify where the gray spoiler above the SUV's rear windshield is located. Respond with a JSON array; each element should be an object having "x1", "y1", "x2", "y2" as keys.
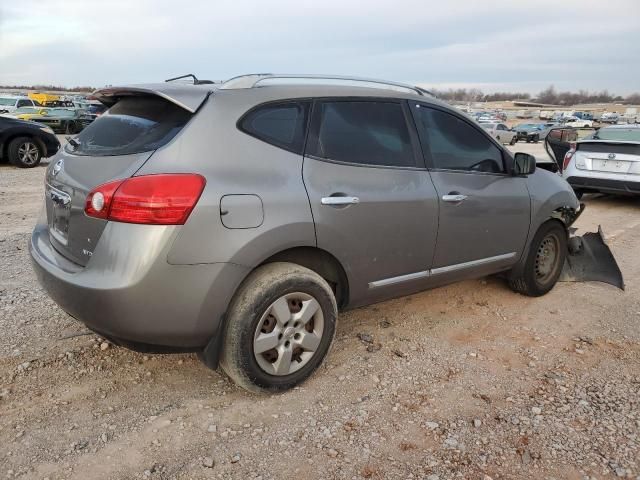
[{"x1": 92, "y1": 83, "x2": 216, "y2": 113}]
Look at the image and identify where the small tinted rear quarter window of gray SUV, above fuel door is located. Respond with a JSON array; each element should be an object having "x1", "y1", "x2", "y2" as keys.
[{"x1": 240, "y1": 102, "x2": 309, "y2": 153}]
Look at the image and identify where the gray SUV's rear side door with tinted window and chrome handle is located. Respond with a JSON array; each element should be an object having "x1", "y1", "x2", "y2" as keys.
[{"x1": 303, "y1": 98, "x2": 438, "y2": 305}]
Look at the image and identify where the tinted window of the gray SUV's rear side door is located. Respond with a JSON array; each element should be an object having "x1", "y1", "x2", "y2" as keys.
[{"x1": 309, "y1": 102, "x2": 415, "y2": 167}]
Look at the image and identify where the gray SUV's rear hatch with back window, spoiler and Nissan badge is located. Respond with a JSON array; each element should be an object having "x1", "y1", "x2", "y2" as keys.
[{"x1": 45, "y1": 86, "x2": 210, "y2": 266}]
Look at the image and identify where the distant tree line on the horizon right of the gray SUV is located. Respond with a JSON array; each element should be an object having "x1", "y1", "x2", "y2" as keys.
[{"x1": 431, "y1": 85, "x2": 640, "y2": 105}]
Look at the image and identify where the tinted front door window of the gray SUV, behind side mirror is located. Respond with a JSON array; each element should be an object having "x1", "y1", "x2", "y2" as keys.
[{"x1": 412, "y1": 104, "x2": 504, "y2": 173}]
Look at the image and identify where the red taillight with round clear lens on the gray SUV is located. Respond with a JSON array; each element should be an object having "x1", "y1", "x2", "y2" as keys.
[{"x1": 84, "y1": 173, "x2": 206, "y2": 225}]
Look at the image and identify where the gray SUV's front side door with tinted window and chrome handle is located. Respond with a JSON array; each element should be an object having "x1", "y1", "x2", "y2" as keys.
[{"x1": 411, "y1": 102, "x2": 530, "y2": 277}]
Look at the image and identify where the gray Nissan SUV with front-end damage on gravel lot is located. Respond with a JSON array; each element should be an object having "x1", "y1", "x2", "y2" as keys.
[{"x1": 30, "y1": 75, "x2": 580, "y2": 391}]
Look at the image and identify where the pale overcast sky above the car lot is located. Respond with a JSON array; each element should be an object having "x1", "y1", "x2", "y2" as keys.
[{"x1": 0, "y1": 0, "x2": 640, "y2": 95}]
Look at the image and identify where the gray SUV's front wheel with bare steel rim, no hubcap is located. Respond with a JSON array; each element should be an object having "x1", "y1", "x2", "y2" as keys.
[{"x1": 509, "y1": 220, "x2": 567, "y2": 297}]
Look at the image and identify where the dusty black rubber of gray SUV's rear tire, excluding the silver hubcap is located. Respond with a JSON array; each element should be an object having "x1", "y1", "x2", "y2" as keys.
[{"x1": 220, "y1": 262, "x2": 338, "y2": 393}]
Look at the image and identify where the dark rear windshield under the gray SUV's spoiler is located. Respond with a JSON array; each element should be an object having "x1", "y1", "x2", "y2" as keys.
[{"x1": 66, "y1": 96, "x2": 191, "y2": 156}]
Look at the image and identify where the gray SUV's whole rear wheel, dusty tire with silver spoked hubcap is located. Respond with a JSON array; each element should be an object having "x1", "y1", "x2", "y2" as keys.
[{"x1": 220, "y1": 262, "x2": 338, "y2": 392}]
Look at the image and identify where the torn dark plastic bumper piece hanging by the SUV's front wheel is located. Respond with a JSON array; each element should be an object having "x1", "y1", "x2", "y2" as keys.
[{"x1": 559, "y1": 227, "x2": 624, "y2": 290}]
